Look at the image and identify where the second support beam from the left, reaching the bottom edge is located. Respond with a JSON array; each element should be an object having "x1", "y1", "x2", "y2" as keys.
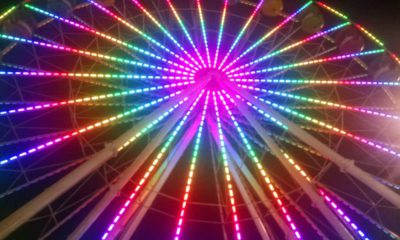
[{"x1": 67, "y1": 98, "x2": 192, "y2": 240}]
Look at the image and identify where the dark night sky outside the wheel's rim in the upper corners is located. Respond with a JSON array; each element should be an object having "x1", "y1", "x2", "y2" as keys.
[{"x1": 0, "y1": 0, "x2": 400, "y2": 54}]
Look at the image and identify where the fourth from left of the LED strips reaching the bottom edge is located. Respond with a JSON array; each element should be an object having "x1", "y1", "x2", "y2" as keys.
[{"x1": 218, "y1": 92, "x2": 301, "y2": 239}]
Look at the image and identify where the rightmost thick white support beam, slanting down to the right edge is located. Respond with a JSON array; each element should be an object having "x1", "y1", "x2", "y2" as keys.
[{"x1": 224, "y1": 84, "x2": 400, "y2": 208}]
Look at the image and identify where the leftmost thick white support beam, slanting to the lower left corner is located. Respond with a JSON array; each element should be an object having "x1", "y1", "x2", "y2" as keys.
[{"x1": 0, "y1": 83, "x2": 205, "y2": 239}]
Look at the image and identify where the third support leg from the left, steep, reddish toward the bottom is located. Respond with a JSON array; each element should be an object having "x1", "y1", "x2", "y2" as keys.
[{"x1": 118, "y1": 118, "x2": 200, "y2": 240}]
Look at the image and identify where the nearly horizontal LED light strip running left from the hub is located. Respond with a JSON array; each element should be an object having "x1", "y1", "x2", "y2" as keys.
[{"x1": 0, "y1": 71, "x2": 194, "y2": 80}]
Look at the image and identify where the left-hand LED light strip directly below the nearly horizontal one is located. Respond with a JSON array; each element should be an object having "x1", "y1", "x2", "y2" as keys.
[{"x1": 0, "y1": 81, "x2": 195, "y2": 116}]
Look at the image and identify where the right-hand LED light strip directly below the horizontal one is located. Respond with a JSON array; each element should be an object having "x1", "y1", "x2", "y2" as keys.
[{"x1": 237, "y1": 84, "x2": 400, "y2": 120}]
